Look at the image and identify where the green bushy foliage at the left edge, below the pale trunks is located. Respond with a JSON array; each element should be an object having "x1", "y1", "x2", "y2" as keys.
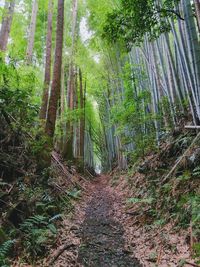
[{"x1": 0, "y1": 59, "x2": 39, "y2": 128}]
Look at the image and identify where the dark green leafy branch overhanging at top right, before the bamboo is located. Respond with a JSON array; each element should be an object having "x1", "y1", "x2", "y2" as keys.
[{"x1": 104, "y1": 0, "x2": 179, "y2": 47}]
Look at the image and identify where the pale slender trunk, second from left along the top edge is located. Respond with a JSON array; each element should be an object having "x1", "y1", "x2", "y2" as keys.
[{"x1": 26, "y1": 0, "x2": 38, "y2": 64}]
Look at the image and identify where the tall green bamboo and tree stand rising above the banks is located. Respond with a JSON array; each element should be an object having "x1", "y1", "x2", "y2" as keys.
[{"x1": 0, "y1": 0, "x2": 200, "y2": 174}]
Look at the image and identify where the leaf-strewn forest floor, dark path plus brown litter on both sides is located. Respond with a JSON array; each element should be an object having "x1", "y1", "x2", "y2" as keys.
[{"x1": 41, "y1": 176, "x2": 198, "y2": 267}]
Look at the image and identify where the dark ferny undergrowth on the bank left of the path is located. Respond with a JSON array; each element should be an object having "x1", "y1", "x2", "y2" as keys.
[{"x1": 0, "y1": 168, "x2": 81, "y2": 266}]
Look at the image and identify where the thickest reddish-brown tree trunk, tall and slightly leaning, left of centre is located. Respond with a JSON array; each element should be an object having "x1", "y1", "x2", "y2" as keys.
[{"x1": 46, "y1": 0, "x2": 64, "y2": 137}]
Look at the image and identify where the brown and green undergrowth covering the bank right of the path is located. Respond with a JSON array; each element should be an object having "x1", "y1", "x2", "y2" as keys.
[{"x1": 113, "y1": 133, "x2": 200, "y2": 264}]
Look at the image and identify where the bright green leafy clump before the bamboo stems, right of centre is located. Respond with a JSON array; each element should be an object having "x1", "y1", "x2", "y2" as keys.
[{"x1": 111, "y1": 64, "x2": 155, "y2": 163}]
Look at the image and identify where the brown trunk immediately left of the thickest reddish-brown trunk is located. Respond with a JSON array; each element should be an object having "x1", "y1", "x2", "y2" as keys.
[{"x1": 40, "y1": 0, "x2": 53, "y2": 120}]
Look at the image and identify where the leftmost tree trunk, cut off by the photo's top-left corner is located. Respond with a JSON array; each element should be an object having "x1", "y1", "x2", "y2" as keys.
[{"x1": 0, "y1": 0, "x2": 15, "y2": 51}]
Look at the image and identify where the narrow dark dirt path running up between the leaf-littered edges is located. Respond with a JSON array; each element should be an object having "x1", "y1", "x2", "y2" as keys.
[{"x1": 78, "y1": 176, "x2": 141, "y2": 267}]
